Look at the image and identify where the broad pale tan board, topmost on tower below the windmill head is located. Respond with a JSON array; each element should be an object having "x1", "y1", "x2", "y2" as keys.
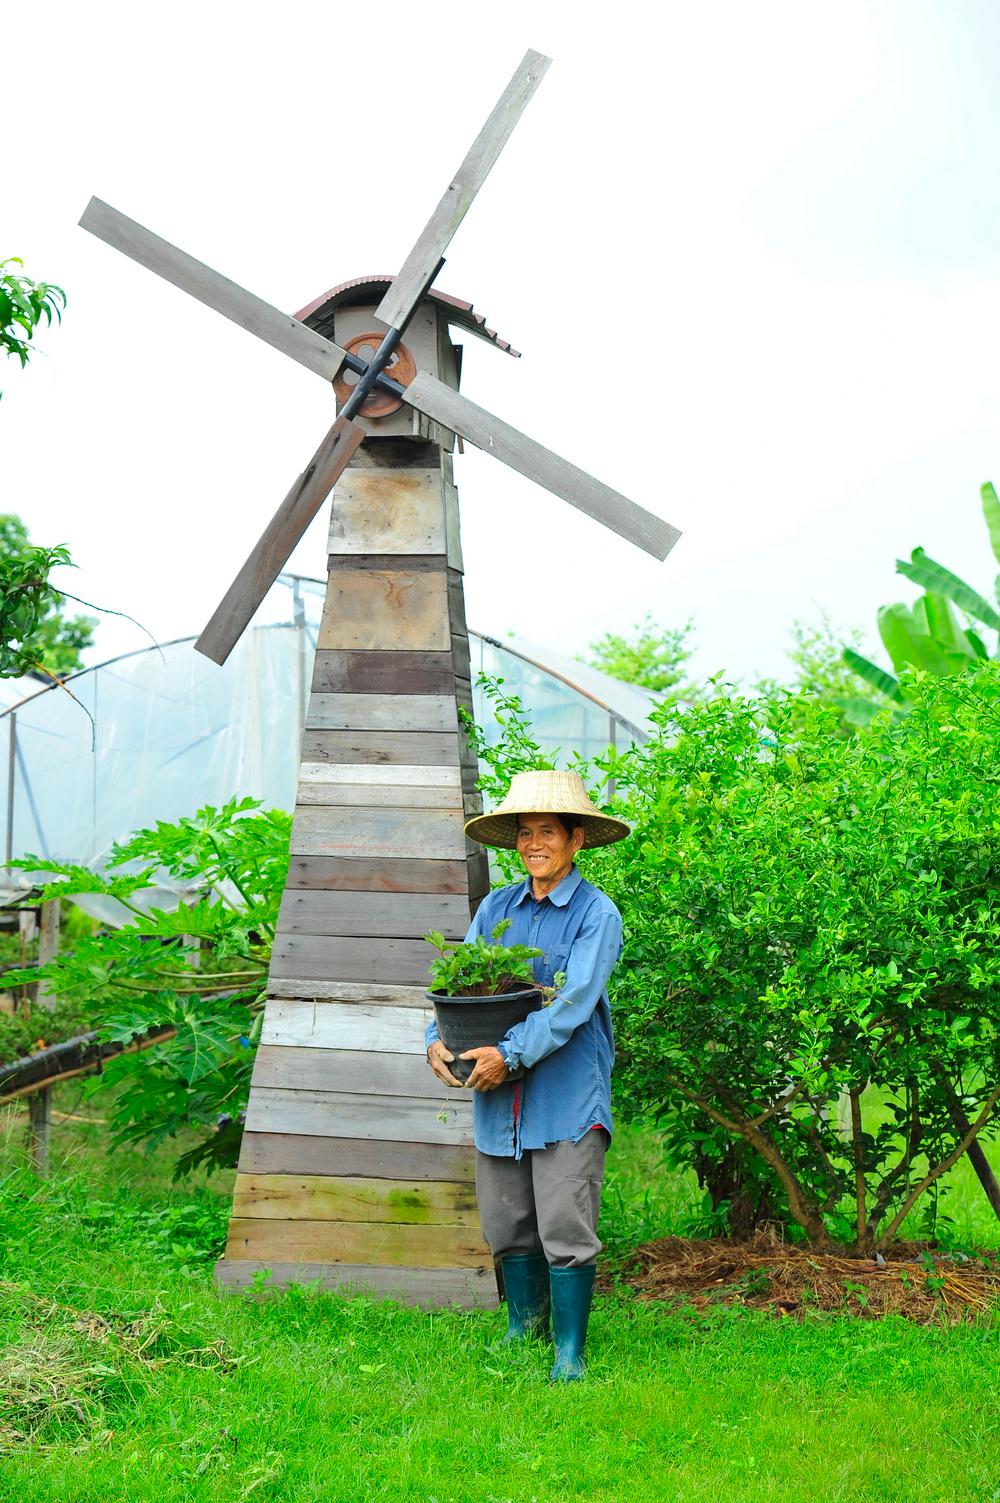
[{"x1": 329, "y1": 467, "x2": 448, "y2": 556}]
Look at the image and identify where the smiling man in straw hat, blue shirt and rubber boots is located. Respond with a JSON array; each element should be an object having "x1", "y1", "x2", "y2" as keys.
[{"x1": 426, "y1": 773, "x2": 630, "y2": 1383}]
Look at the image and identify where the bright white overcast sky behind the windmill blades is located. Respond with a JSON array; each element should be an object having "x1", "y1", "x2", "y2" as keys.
[{"x1": 0, "y1": 0, "x2": 1000, "y2": 676}]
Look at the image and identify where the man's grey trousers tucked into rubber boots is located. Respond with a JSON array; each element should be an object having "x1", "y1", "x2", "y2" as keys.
[{"x1": 475, "y1": 1127, "x2": 608, "y2": 1269}]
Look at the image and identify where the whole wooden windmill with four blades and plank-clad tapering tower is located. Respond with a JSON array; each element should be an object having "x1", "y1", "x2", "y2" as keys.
[{"x1": 80, "y1": 53, "x2": 680, "y2": 1306}]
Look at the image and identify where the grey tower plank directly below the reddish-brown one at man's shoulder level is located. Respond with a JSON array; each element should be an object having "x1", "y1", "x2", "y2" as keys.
[{"x1": 278, "y1": 890, "x2": 471, "y2": 937}]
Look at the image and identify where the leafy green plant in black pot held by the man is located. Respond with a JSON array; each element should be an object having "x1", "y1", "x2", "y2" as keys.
[{"x1": 424, "y1": 918, "x2": 552, "y2": 1082}]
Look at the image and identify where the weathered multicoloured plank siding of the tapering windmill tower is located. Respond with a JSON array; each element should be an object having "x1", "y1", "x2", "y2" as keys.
[{"x1": 218, "y1": 420, "x2": 496, "y2": 1306}]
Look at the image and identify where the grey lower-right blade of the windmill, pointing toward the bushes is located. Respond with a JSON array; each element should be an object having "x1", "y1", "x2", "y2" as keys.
[{"x1": 405, "y1": 371, "x2": 680, "y2": 559}]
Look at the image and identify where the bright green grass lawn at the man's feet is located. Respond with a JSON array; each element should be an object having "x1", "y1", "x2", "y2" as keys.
[{"x1": 0, "y1": 1114, "x2": 1000, "y2": 1503}]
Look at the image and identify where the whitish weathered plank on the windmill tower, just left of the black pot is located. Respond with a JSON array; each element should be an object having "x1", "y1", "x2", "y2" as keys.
[{"x1": 260, "y1": 987, "x2": 432, "y2": 1061}]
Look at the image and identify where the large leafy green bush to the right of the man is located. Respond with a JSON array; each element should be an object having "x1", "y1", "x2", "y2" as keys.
[{"x1": 472, "y1": 663, "x2": 1000, "y2": 1252}]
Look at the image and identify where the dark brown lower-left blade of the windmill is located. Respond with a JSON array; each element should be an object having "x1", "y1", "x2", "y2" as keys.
[{"x1": 194, "y1": 416, "x2": 364, "y2": 663}]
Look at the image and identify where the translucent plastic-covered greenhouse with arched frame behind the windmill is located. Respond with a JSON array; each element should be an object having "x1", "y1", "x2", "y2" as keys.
[{"x1": 0, "y1": 574, "x2": 654, "y2": 866}]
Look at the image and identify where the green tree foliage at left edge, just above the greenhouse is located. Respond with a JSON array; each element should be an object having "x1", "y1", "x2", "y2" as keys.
[{"x1": 0, "y1": 513, "x2": 96, "y2": 678}]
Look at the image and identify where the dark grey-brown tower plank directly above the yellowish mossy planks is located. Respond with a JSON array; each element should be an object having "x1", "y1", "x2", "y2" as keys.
[{"x1": 239, "y1": 1132, "x2": 475, "y2": 1184}]
